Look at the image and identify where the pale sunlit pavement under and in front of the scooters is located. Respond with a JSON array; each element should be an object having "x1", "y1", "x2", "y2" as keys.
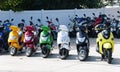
[{"x1": 0, "y1": 38, "x2": 120, "y2": 72}]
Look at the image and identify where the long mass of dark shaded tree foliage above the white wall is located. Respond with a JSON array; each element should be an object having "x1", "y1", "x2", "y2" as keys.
[{"x1": 0, "y1": 0, "x2": 106, "y2": 11}]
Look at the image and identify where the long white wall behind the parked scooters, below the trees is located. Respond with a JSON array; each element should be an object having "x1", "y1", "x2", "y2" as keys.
[{"x1": 0, "y1": 7, "x2": 120, "y2": 25}]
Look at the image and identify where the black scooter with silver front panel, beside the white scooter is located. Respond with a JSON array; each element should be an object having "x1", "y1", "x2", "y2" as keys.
[{"x1": 76, "y1": 26, "x2": 90, "y2": 61}]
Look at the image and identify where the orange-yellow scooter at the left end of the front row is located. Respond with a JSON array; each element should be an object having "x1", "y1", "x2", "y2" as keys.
[{"x1": 8, "y1": 26, "x2": 24, "y2": 56}]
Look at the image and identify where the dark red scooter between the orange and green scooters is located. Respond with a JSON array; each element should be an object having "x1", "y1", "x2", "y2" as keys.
[{"x1": 24, "y1": 26, "x2": 38, "y2": 57}]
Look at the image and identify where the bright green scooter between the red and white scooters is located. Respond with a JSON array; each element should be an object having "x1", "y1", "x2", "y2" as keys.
[{"x1": 39, "y1": 26, "x2": 53, "y2": 58}]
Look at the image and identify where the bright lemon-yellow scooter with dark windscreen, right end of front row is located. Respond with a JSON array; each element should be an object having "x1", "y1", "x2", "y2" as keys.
[{"x1": 96, "y1": 29, "x2": 114, "y2": 64}]
